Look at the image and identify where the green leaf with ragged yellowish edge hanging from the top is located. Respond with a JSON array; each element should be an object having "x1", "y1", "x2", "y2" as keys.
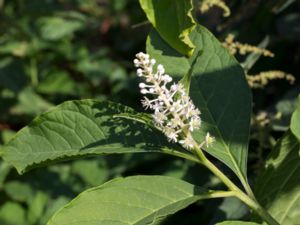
[{"x1": 140, "y1": 0, "x2": 196, "y2": 56}]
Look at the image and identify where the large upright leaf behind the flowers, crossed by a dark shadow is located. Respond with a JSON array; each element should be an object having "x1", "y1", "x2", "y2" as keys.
[{"x1": 147, "y1": 26, "x2": 252, "y2": 180}]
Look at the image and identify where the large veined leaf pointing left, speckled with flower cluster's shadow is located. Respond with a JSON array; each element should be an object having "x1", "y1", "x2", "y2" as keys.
[{"x1": 2, "y1": 100, "x2": 188, "y2": 173}]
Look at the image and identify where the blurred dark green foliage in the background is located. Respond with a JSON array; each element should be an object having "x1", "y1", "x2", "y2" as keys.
[{"x1": 0, "y1": 0, "x2": 300, "y2": 225}]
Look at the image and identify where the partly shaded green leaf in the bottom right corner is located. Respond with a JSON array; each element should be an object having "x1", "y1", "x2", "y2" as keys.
[{"x1": 256, "y1": 131, "x2": 300, "y2": 225}]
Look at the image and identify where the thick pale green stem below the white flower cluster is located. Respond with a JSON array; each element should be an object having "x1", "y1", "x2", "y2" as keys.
[{"x1": 194, "y1": 145, "x2": 279, "y2": 225}]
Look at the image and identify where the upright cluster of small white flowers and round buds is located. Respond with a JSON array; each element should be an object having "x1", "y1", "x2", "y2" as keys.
[{"x1": 134, "y1": 52, "x2": 201, "y2": 148}]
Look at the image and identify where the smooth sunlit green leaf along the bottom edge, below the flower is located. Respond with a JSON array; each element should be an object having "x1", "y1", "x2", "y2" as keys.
[{"x1": 48, "y1": 176, "x2": 208, "y2": 225}]
